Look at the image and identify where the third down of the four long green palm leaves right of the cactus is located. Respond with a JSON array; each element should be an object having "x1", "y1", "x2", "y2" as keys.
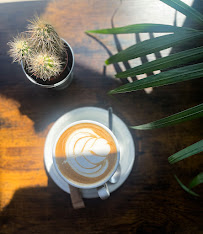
[{"x1": 116, "y1": 46, "x2": 203, "y2": 78}]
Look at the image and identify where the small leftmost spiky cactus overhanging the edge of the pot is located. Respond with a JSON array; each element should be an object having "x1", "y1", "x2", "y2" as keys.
[{"x1": 8, "y1": 33, "x2": 31, "y2": 63}]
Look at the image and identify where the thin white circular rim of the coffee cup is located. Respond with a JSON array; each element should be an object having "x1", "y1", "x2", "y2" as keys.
[{"x1": 52, "y1": 120, "x2": 120, "y2": 189}]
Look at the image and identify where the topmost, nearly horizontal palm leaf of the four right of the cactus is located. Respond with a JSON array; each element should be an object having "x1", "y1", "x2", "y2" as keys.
[{"x1": 86, "y1": 24, "x2": 194, "y2": 34}]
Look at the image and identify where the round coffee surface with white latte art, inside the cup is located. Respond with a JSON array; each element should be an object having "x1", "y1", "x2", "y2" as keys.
[{"x1": 55, "y1": 123, "x2": 117, "y2": 186}]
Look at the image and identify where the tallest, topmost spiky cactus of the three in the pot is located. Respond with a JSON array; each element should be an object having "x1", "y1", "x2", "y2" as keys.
[{"x1": 27, "y1": 16, "x2": 64, "y2": 55}]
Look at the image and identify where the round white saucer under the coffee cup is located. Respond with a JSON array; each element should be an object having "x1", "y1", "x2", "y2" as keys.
[{"x1": 44, "y1": 107, "x2": 135, "y2": 198}]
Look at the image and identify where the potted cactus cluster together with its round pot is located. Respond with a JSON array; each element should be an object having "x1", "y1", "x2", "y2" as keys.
[{"x1": 8, "y1": 17, "x2": 74, "y2": 88}]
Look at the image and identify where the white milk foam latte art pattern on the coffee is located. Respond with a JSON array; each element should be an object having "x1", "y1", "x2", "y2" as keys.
[{"x1": 65, "y1": 128, "x2": 110, "y2": 177}]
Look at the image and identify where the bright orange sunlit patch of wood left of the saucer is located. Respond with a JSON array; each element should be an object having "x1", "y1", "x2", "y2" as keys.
[{"x1": 0, "y1": 95, "x2": 49, "y2": 210}]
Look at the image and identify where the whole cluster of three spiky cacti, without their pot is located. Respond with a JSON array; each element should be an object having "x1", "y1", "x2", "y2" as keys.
[{"x1": 8, "y1": 16, "x2": 66, "y2": 81}]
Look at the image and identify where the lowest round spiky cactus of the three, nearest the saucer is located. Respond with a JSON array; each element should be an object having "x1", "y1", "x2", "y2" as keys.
[{"x1": 28, "y1": 53, "x2": 63, "y2": 81}]
